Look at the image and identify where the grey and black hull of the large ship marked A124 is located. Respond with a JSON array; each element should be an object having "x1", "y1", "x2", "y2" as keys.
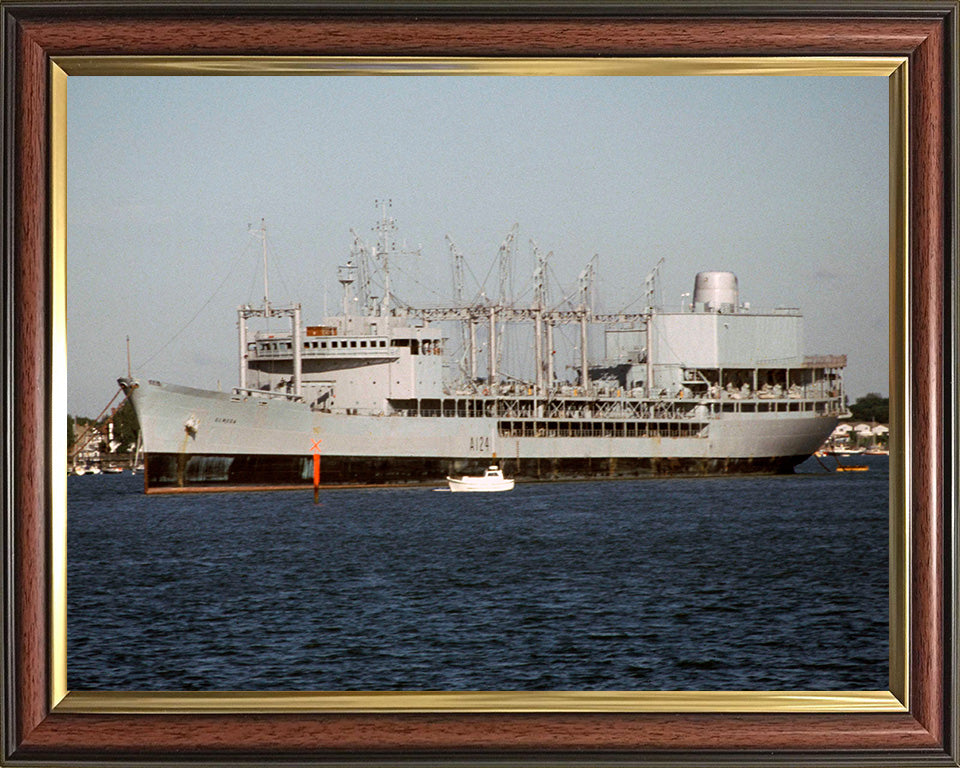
[{"x1": 125, "y1": 381, "x2": 836, "y2": 491}]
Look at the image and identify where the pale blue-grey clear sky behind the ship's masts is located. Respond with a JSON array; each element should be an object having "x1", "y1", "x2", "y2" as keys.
[{"x1": 67, "y1": 76, "x2": 888, "y2": 416}]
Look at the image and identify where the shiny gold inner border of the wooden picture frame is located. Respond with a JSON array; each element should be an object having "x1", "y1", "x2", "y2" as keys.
[{"x1": 49, "y1": 56, "x2": 912, "y2": 714}]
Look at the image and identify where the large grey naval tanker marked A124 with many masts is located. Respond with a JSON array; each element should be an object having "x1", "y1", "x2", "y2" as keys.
[{"x1": 120, "y1": 216, "x2": 846, "y2": 492}]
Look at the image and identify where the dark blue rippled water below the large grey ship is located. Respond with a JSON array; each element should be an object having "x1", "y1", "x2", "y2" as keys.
[{"x1": 67, "y1": 457, "x2": 889, "y2": 690}]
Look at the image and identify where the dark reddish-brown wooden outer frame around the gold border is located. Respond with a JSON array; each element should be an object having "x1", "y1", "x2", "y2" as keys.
[{"x1": 0, "y1": 0, "x2": 960, "y2": 766}]
